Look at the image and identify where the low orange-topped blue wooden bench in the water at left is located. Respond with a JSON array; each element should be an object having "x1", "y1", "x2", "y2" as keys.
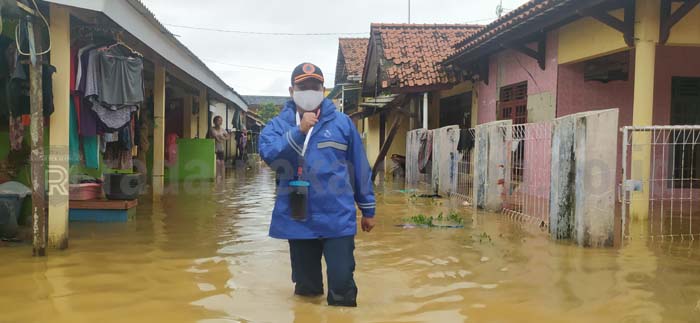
[{"x1": 68, "y1": 199, "x2": 139, "y2": 222}]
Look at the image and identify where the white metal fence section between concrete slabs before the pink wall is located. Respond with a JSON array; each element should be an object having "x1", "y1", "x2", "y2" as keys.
[{"x1": 501, "y1": 122, "x2": 552, "y2": 225}]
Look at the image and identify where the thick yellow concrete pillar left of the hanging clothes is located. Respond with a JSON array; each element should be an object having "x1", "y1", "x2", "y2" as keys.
[{"x1": 48, "y1": 4, "x2": 70, "y2": 249}]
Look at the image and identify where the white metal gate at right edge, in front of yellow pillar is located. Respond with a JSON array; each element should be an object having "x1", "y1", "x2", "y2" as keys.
[{"x1": 620, "y1": 126, "x2": 700, "y2": 239}]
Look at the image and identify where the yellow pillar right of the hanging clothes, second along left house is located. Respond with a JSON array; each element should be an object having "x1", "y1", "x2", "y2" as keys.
[{"x1": 153, "y1": 64, "x2": 165, "y2": 196}]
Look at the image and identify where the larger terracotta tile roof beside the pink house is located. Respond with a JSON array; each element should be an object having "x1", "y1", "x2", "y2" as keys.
[{"x1": 371, "y1": 24, "x2": 482, "y2": 89}]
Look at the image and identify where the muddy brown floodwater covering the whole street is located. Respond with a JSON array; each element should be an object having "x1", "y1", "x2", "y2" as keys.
[{"x1": 0, "y1": 169, "x2": 700, "y2": 323}]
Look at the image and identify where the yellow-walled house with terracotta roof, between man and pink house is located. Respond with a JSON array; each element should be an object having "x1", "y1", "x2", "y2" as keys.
[{"x1": 360, "y1": 24, "x2": 480, "y2": 182}]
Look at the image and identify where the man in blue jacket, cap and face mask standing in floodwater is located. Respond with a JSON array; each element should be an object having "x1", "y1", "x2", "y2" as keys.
[{"x1": 259, "y1": 63, "x2": 376, "y2": 306}]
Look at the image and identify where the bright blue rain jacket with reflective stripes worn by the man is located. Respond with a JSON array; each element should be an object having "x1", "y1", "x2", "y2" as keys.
[{"x1": 259, "y1": 99, "x2": 376, "y2": 239}]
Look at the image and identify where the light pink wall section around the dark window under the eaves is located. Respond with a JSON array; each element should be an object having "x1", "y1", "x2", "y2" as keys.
[{"x1": 477, "y1": 31, "x2": 559, "y2": 124}]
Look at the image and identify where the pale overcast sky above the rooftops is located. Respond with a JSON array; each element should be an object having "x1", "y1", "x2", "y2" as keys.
[{"x1": 142, "y1": 0, "x2": 525, "y2": 95}]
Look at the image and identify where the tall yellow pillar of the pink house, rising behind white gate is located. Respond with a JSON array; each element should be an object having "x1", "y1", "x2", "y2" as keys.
[{"x1": 630, "y1": 0, "x2": 660, "y2": 220}]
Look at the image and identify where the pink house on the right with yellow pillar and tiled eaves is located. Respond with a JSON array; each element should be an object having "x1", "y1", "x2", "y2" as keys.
[{"x1": 445, "y1": 0, "x2": 700, "y2": 230}]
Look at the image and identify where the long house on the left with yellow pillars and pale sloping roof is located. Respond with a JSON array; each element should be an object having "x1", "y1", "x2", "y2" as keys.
[{"x1": 3, "y1": 0, "x2": 248, "y2": 251}]
